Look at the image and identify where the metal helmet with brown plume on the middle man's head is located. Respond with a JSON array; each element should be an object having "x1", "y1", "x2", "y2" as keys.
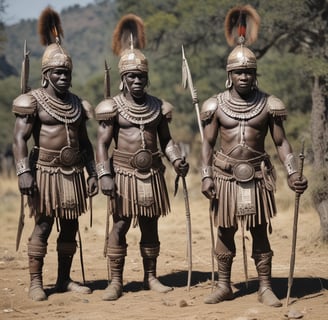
[{"x1": 112, "y1": 13, "x2": 148, "y2": 76}]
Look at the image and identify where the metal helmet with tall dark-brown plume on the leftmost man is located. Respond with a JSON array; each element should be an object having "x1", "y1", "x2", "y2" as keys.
[{"x1": 38, "y1": 6, "x2": 73, "y2": 73}]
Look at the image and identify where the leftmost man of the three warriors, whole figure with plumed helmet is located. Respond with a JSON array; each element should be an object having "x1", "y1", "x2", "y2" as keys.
[{"x1": 13, "y1": 7, "x2": 98, "y2": 301}]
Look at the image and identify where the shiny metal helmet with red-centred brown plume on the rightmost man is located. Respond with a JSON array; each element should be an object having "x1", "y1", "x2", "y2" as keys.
[{"x1": 224, "y1": 5, "x2": 261, "y2": 71}]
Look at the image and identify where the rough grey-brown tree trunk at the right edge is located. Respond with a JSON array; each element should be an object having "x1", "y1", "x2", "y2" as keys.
[{"x1": 311, "y1": 76, "x2": 328, "y2": 242}]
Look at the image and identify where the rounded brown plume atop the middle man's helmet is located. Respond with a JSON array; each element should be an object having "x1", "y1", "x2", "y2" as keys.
[{"x1": 112, "y1": 13, "x2": 146, "y2": 56}]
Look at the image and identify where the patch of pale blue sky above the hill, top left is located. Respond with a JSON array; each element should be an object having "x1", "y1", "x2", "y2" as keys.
[{"x1": 3, "y1": 0, "x2": 94, "y2": 25}]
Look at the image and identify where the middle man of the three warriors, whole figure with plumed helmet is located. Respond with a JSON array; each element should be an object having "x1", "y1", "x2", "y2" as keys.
[{"x1": 96, "y1": 14, "x2": 189, "y2": 300}]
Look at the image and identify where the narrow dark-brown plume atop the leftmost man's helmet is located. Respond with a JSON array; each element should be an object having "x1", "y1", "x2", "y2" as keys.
[{"x1": 38, "y1": 6, "x2": 64, "y2": 46}]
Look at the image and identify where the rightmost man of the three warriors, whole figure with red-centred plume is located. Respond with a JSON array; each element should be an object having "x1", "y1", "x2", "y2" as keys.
[{"x1": 201, "y1": 5, "x2": 307, "y2": 307}]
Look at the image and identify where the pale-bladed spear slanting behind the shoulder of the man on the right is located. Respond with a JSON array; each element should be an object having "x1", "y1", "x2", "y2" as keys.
[{"x1": 182, "y1": 45, "x2": 214, "y2": 289}]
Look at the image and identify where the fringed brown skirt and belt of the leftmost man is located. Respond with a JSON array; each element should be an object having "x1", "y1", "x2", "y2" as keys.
[{"x1": 29, "y1": 148, "x2": 87, "y2": 219}]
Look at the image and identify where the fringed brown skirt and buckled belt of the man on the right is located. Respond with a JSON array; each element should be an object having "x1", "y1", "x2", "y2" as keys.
[{"x1": 212, "y1": 152, "x2": 277, "y2": 230}]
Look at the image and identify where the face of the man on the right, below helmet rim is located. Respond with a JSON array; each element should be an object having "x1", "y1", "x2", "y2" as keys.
[{"x1": 231, "y1": 69, "x2": 256, "y2": 96}]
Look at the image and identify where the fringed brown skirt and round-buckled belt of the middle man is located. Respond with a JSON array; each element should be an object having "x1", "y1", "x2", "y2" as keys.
[{"x1": 113, "y1": 149, "x2": 170, "y2": 227}]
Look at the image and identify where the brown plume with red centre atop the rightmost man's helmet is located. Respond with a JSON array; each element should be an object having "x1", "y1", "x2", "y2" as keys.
[{"x1": 224, "y1": 4, "x2": 261, "y2": 46}]
